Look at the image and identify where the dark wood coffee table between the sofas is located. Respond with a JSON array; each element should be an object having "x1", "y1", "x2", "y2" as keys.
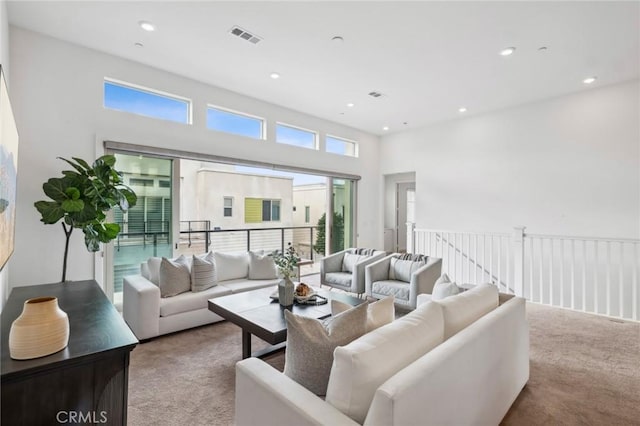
[{"x1": 209, "y1": 287, "x2": 365, "y2": 359}]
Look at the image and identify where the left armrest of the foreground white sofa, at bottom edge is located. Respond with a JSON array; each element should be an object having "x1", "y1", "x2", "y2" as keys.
[{"x1": 235, "y1": 358, "x2": 357, "y2": 426}]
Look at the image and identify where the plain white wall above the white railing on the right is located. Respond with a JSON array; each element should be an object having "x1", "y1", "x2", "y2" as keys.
[{"x1": 380, "y1": 80, "x2": 640, "y2": 238}]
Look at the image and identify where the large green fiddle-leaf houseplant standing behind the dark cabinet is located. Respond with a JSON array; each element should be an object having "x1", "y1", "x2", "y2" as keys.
[{"x1": 34, "y1": 155, "x2": 138, "y2": 282}]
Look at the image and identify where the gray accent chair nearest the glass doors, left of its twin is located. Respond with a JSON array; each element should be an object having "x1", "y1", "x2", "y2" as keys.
[{"x1": 320, "y1": 248, "x2": 387, "y2": 295}]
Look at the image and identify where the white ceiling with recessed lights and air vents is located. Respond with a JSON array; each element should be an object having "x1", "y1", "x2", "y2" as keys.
[{"x1": 8, "y1": 1, "x2": 640, "y2": 134}]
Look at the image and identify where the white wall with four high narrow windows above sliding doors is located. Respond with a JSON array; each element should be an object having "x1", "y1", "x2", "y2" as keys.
[{"x1": 9, "y1": 27, "x2": 382, "y2": 285}]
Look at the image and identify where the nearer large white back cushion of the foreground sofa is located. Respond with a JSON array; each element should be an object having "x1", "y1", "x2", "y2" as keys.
[{"x1": 326, "y1": 303, "x2": 444, "y2": 424}]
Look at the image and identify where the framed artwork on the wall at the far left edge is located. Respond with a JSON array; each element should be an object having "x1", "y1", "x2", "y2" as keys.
[{"x1": 0, "y1": 66, "x2": 18, "y2": 270}]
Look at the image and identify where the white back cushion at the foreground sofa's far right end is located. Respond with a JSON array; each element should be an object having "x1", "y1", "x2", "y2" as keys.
[{"x1": 433, "y1": 284, "x2": 498, "y2": 339}]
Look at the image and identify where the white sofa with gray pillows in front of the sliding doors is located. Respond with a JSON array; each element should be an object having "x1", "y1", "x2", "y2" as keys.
[{"x1": 122, "y1": 252, "x2": 280, "y2": 340}]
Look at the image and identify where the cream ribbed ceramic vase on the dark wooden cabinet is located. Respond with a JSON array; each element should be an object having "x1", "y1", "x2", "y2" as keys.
[{"x1": 9, "y1": 297, "x2": 69, "y2": 360}]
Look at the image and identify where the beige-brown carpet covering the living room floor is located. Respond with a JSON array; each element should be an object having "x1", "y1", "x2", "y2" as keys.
[{"x1": 128, "y1": 304, "x2": 640, "y2": 426}]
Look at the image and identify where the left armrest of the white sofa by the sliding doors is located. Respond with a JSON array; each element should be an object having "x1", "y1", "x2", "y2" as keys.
[{"x1": 122, "y1": 275, "x2": 160, "y2": 340}]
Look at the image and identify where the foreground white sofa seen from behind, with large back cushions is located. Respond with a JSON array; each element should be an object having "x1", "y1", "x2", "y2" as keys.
[{"x1": 235, "y1": 285, "x2": 529, "y2": 426}]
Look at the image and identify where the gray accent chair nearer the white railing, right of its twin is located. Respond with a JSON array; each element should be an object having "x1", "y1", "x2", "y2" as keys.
[{"x1": 365, "y1": 253, "x2": 442, "y2": 309}]
